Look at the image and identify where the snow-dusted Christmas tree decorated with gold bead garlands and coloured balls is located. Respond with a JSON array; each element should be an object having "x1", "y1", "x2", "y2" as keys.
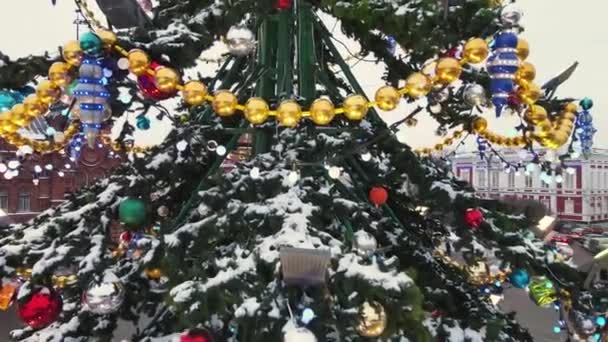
[{"x1": 0, "y1": 0, "x2": 605, "y2": 342}]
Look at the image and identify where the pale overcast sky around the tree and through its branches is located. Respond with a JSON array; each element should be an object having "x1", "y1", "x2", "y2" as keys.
[{"x1": 0, "y1": 0, "x2": 608, "y2": 147}]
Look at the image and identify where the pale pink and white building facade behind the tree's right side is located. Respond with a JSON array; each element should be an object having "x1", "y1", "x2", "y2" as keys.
[{"x1": 452, "y1": 149, "x2": 608, "y2": 223}]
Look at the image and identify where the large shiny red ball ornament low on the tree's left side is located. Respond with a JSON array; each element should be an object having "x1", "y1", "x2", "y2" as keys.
[{"x1": 17, "y1": 287, "x2": 63, "y2": 329}]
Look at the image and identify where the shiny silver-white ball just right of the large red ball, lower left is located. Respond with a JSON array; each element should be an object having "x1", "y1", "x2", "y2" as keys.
[{"x1": 82, "y1": 274, "x2": 125, "y2": 315}]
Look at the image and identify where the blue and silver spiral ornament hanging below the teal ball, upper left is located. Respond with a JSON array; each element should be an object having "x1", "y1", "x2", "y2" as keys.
[{"x1": 74, "y1": 56, "x2": 110, "y2": 148}]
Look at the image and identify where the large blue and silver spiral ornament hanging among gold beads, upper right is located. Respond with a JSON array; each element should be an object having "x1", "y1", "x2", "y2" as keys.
[{"x1": 487, "y1": 30, "x2": 519, "y2": 117}]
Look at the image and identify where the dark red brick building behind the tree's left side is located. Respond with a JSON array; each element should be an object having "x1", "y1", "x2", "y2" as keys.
[{"x1": 0, "y1": 140, "x2": 122, "y2": 223}]
